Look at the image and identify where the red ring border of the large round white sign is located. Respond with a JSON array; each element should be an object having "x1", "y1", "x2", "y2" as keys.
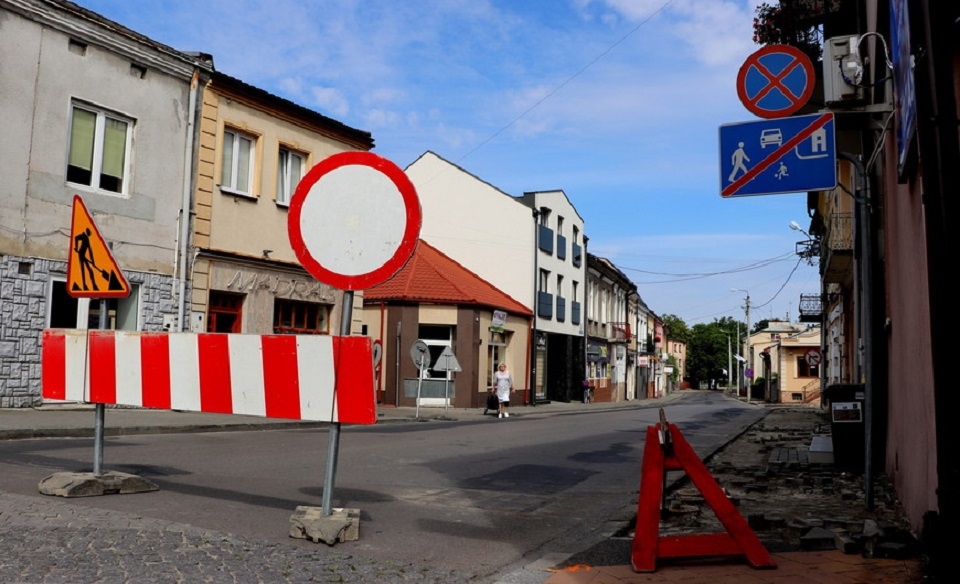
[{"x1": 287, "y1": 151, "x2": 423, "y2": 290}]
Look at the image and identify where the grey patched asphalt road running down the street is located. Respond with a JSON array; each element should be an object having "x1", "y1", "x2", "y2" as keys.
[{"x1": 0, "y1": 392, "x2": 761, "y2": 581}]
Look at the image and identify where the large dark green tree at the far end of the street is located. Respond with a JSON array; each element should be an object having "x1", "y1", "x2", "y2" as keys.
[{"x1": 687, "y1": 316, "x2": 747, "y2": 384}]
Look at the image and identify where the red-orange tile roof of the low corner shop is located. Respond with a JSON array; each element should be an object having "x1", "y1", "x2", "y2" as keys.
[{"x1": 363, "y1": 239, "x2": 533, "y2": 316}]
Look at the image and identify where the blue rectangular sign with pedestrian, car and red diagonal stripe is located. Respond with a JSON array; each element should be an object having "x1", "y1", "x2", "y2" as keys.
[{"x1": 720, "y1": 113, "x2": 837, "y2": 197}]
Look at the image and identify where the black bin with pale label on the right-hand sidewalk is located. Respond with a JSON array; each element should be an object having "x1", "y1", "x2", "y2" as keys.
[{"x1": 823, "y1": 383, "x2": 866, "y2": 472}]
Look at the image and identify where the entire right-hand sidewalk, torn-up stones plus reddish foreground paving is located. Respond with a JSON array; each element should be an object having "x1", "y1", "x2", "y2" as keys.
[{"x1": 547, "y1": 406, "x2": 935, "y2": 584}]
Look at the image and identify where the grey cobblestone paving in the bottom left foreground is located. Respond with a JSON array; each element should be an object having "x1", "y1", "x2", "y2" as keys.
[{"x1": 0, "y1": 492, "x2": 472, "y2": 584}]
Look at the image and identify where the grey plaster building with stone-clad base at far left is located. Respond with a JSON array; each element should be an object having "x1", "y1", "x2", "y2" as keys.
[{"x1": 0, "y1": 0, "x2": 212, "y2": 407}]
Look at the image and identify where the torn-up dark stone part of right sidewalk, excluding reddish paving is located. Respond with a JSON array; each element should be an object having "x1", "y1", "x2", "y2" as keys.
[{"x1": 663, "y1": 407, "x2": 919, "y2": 556}]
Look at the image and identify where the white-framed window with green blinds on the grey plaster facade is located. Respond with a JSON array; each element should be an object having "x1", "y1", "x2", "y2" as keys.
[{"x1": 67, "y1": 104, "x2": 133, "y2": 194}]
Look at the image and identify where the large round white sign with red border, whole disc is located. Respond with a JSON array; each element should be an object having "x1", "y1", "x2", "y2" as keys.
[{"x1": 287, "y1": 152, "x2": 422, "y2": 290}]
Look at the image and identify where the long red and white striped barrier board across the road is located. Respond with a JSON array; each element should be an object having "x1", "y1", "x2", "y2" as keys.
[{"x1": 41, "y1": 329, "x2": 377, "y2": 424}]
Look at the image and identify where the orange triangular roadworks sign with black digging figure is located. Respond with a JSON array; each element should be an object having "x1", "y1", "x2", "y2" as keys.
[{"x1": 67, "y1": 195, "x2": 130, "y2": 298}]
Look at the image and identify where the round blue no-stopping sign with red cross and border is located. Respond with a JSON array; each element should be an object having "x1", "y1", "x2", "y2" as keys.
[{"x1": 737, "y1": 45, "x2": 816, "y2": 118}]
